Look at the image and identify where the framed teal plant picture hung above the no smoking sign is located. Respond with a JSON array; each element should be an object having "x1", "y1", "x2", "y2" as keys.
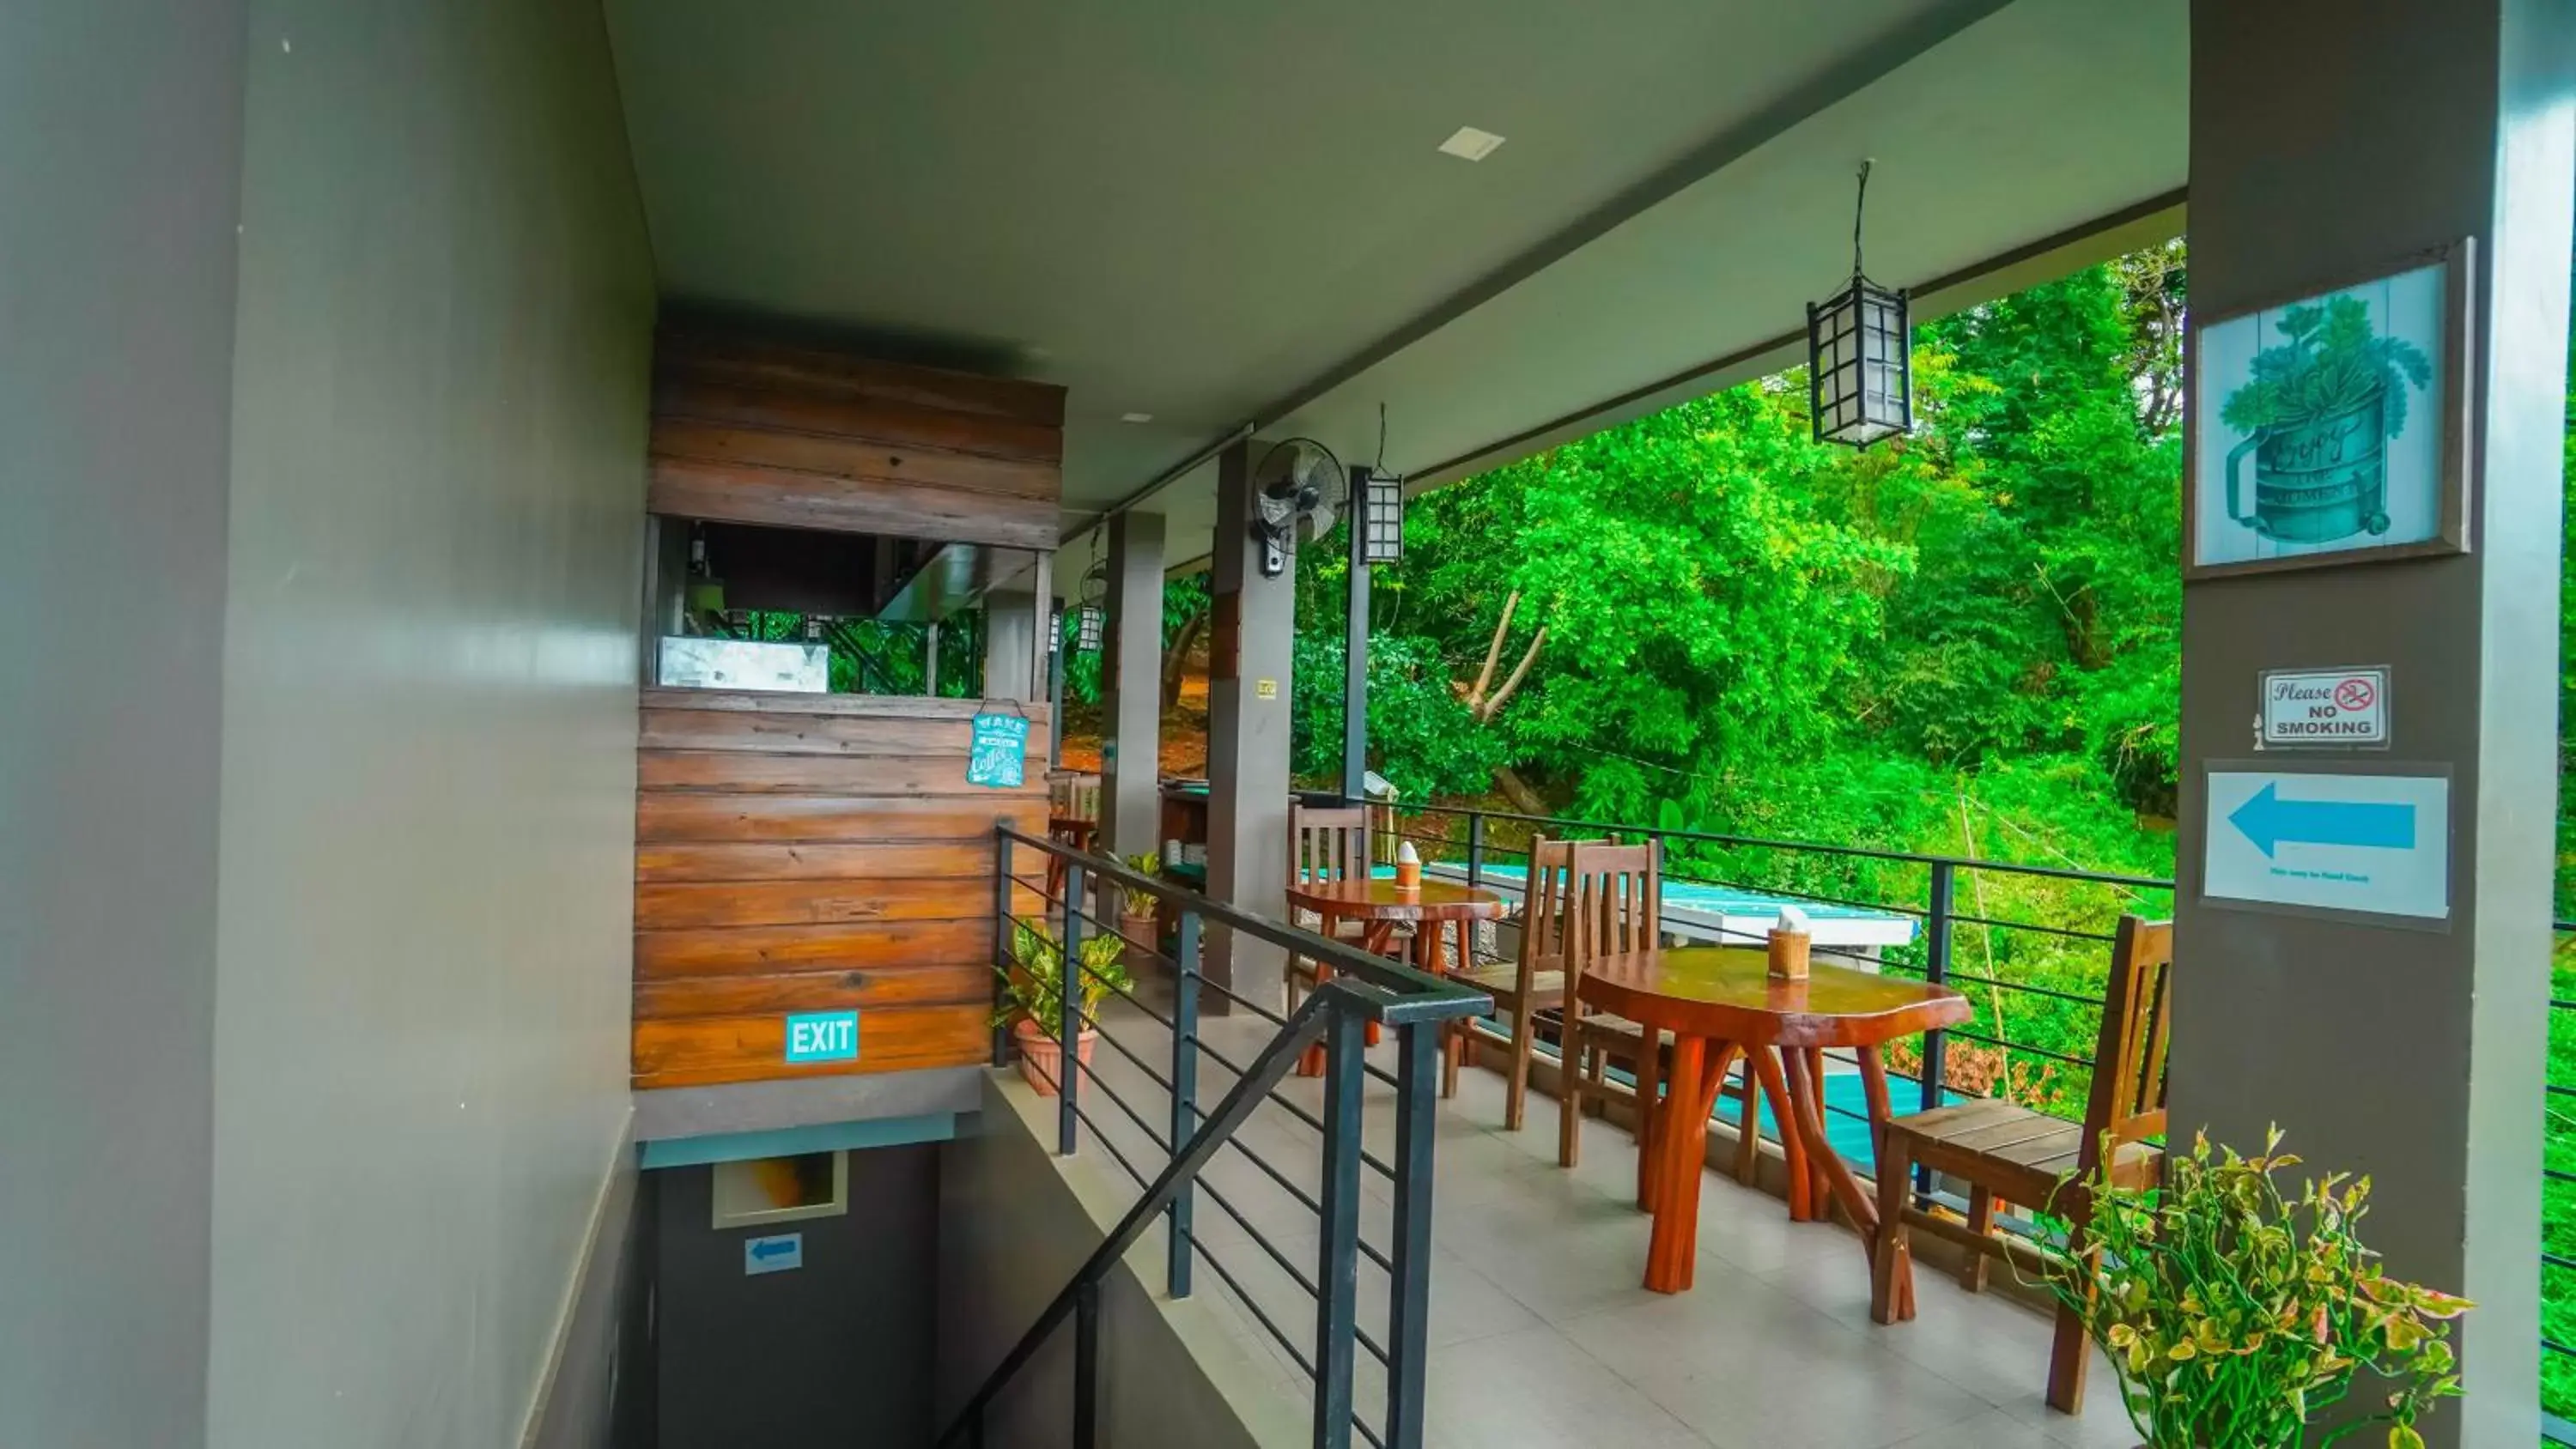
[{"x1": 2182, "y1": 239, "x2": 2473, "y2": 579}]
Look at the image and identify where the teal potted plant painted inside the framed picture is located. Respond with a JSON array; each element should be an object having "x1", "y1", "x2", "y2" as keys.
[{"x1": 2218, "y1": 296, "x2": 2432, "y2": 543}]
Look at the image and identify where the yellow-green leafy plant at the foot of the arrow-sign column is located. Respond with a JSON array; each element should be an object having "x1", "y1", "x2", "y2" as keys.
[{"x1": 2048, "y1": 1127, "x2": 2470, "y2": 1449}]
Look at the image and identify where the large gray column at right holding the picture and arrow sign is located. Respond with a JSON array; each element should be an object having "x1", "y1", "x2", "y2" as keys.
[{"x1": 2172, "y1": 0, "x2": 2576, "y2": 1446}]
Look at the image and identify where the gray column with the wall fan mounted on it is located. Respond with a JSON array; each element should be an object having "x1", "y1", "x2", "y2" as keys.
[{"x1": 1203, "y1": 440, "x2": 1296, "y2": 1009}]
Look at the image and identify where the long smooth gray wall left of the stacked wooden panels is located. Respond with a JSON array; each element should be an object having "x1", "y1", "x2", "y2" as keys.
[{"x1": 206, "y1": 0, "x2": 654, "y2": 1449}]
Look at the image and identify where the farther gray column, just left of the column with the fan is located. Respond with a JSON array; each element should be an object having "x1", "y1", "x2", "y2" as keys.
[{"x1": 1100, "y1": 512, "x2": 1162, "y2": 854}]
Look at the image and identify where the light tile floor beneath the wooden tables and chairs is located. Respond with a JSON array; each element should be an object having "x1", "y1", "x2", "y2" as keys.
[{"x1": 1084, "y1": 1009, "x2": 2138, "y2": 1449}]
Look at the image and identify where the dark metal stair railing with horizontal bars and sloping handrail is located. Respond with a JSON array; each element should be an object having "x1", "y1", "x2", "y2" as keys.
[{"x1": 938, "y1": 823, "x2": 1492, "y2": 1449}]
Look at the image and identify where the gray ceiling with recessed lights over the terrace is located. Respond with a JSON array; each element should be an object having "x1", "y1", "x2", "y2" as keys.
[{"x1": 608, "y1": 0, "x2": 2187, "y2": 574}]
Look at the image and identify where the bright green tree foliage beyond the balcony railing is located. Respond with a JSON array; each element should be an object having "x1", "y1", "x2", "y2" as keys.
[{"x1": 1298, "y1": 242, "x2": 2182, "y2": 870}]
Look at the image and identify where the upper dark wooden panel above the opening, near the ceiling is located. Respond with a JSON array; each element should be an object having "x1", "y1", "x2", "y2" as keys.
[{"x1": 647, "y1": 332, "x2": 1064, "y2": 549}]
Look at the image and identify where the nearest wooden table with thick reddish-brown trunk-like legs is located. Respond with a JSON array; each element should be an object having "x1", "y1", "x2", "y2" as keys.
[{"x1": 1579, "y1": 947, "x2": 1968, "y2": 1307}]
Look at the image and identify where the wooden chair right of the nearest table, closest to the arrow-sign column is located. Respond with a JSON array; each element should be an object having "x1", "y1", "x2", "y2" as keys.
[{"x1": 1870, "y1": 916, "x2": 2174, "y2": 1413}]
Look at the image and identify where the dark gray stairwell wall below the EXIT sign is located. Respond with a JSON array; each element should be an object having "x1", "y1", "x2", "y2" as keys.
[{"x1": 654, "y1": 1143, "x2": 940, "y2": 1449}]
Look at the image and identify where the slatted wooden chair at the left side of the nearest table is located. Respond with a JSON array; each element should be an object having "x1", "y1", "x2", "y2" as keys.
[{"x1": 1556, "y1": 841, "x2": 1664, "y2": 1202}]
